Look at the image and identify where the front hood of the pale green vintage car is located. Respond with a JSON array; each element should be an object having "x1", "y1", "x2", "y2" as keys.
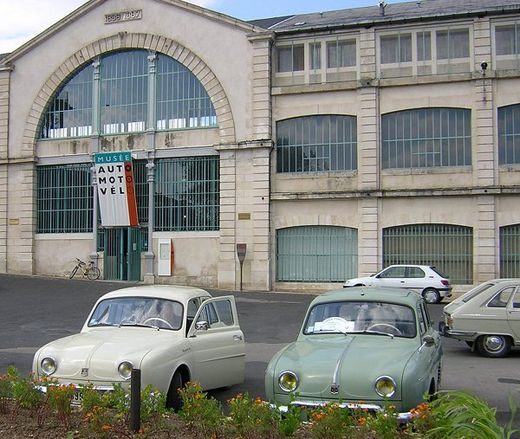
[{"x1": 275, "y1": 334, "x2": 419, "y2": 400}]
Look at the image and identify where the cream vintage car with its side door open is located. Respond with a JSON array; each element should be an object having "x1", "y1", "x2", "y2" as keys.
[{"x1": 33, "y1": 286, "x2": 245, "y2": 408}]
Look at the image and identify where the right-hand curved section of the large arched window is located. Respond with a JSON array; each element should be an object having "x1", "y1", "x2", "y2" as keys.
[{"x1": 157, "y1": 54, "x2": 217, "y2": 130}]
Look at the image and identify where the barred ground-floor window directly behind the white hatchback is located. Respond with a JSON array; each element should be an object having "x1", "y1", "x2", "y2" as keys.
[{"x1": 383, "y1": 224, "x2": 473, "y2": 284}]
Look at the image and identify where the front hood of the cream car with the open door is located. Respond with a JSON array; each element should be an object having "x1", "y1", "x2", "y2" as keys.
[{"x1": 36, "y1": 327, "x2": 182, "y2": 382}]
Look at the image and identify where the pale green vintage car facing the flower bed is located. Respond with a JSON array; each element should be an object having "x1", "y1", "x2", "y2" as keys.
[{"x1": 265, "y1": 287, "x2": 442, "y2": 421}]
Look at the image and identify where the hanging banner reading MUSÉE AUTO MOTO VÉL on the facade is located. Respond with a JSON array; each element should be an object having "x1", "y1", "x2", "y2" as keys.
[{"x1": 95, "y1": 151, "x2": 139, "y2": 227}]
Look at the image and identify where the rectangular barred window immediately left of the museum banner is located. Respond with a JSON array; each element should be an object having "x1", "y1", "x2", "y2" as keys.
[{"x1": 36, "y1": 163, "x2": 93, "y2": 233}]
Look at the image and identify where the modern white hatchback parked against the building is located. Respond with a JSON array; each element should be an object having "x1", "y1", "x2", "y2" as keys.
[{"x1": 343, "y1": 265, "x2": 452, "y2": 303}]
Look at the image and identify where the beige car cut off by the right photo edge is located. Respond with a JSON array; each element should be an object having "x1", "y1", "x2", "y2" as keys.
[{"x1": 439, "y1": 279, "x2": 520, "y2": 357}]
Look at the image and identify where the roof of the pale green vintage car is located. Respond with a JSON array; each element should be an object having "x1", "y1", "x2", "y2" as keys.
[{"x1": 312, "y1": 287, "x2": 421, "y2": 307}]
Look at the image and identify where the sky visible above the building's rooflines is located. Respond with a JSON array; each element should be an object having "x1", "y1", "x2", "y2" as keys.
[{"x1": 0, "y1": 0, "x2": 404, "y2": 53}]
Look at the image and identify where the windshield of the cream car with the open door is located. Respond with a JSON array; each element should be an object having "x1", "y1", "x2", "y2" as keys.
[{"x1": 88, "y1": 297, "x2": 183, "y2": 330}]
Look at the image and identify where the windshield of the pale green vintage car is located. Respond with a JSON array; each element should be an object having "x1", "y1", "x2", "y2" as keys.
[{"x1": 303, "y1": 301, "x2": 417, "y2": 338}]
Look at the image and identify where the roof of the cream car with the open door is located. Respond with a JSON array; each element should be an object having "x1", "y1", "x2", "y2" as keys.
[{"x1": 99, "y1": 285, "x2": 211, "y2": 302}]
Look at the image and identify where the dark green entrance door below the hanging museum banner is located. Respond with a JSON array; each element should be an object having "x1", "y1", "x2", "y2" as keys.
[{"x1": 104, "y1": 227, "x2": 141, "y2": 281}]
